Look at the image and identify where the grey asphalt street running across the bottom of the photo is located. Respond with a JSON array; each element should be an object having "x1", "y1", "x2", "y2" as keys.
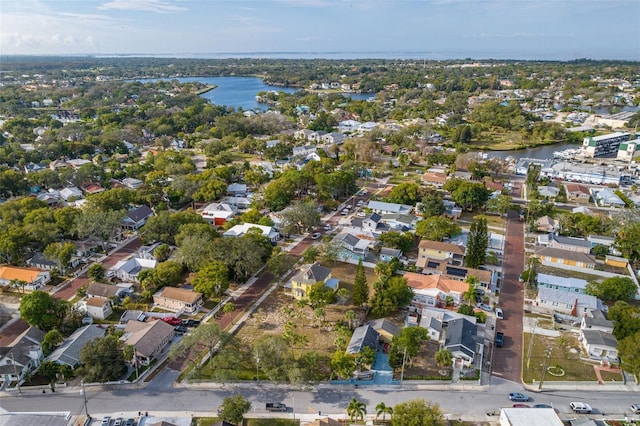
[{"x1": 0, "y1": 378, "x2": 639, "y2": 421}]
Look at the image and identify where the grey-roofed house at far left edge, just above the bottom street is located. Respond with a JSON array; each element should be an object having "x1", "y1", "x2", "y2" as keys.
[{"x1": 0, "y1": 327, "x2": 45, "y2": 388}]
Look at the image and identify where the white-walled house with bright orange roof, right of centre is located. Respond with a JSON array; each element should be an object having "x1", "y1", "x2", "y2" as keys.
[{"x1": 404, "y1": 272, "x2": 469, "y2": 309}]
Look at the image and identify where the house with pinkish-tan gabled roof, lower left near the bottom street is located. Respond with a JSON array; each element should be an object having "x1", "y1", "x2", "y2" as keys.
[{"x1": 121, "y1": 320, "x2": 175, "y2": 365}]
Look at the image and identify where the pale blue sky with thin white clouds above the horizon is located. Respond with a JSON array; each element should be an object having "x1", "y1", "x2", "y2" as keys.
[{"x1": 0, "y1": 0, "x2": 640, "y2": 60}]
